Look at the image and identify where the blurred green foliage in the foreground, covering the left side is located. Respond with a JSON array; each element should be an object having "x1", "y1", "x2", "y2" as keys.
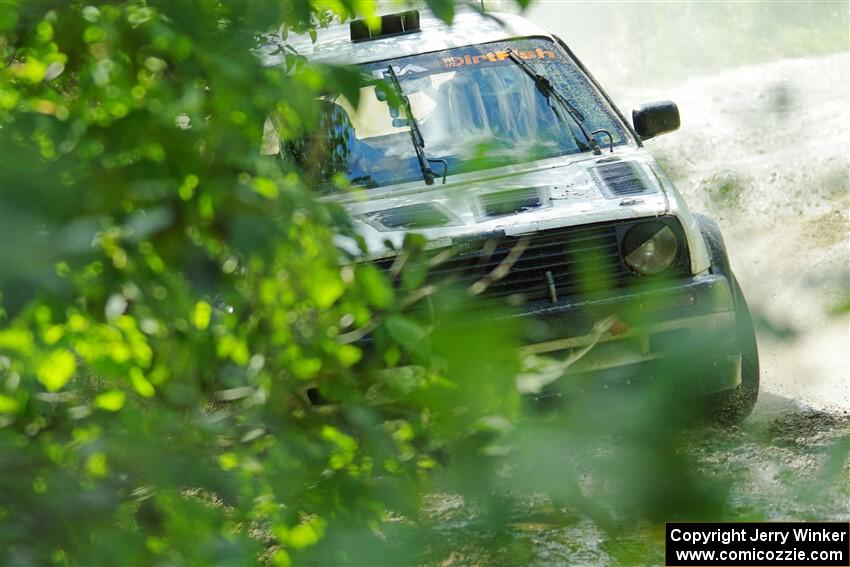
[{"x1": 0, "y1": 0, "x2": 841, "y2": 566}]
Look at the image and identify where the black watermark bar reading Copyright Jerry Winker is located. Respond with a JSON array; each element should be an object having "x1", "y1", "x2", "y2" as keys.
[{"x1": 665, "y1": 522, "x2": 850, "y2": 567}]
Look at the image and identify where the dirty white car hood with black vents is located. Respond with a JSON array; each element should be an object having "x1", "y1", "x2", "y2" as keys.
[{"x1": 325, "y1": 147, "x2": 675, "y2": 258}]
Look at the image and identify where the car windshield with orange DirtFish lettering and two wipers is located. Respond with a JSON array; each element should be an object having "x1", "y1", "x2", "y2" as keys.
[{"x1": 274, "y1": 38, "x2": 626, "y2": 192}]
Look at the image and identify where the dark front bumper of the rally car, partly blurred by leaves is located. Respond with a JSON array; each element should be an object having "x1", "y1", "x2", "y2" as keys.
[{"x1": 500, "y1": 274, "x2": 741, "y2": 396}]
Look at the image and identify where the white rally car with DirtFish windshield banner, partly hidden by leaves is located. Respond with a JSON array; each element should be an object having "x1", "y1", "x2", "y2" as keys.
[{"x1": 264, "y1": 7, "x2": 759, "y2": 420}]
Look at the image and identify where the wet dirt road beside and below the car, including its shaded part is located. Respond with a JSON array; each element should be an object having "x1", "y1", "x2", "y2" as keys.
[{"x1": 424, "y1": 53, "x2": 850, "y2": 567}]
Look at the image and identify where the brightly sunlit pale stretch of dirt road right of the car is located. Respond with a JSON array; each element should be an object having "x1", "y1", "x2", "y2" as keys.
[{"x1": 623, "y1": 53, "x2": 850, "y2": 417}]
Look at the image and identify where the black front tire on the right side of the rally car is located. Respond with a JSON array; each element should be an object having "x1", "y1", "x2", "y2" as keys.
[{"x1": 706, "y1": 276, "x2": 759, "y2": 425}]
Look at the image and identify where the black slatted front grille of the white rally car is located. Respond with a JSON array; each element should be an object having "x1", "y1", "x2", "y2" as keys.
[{"x1": 377, "y1": 223, "x2": 687, "y2": 304}]
